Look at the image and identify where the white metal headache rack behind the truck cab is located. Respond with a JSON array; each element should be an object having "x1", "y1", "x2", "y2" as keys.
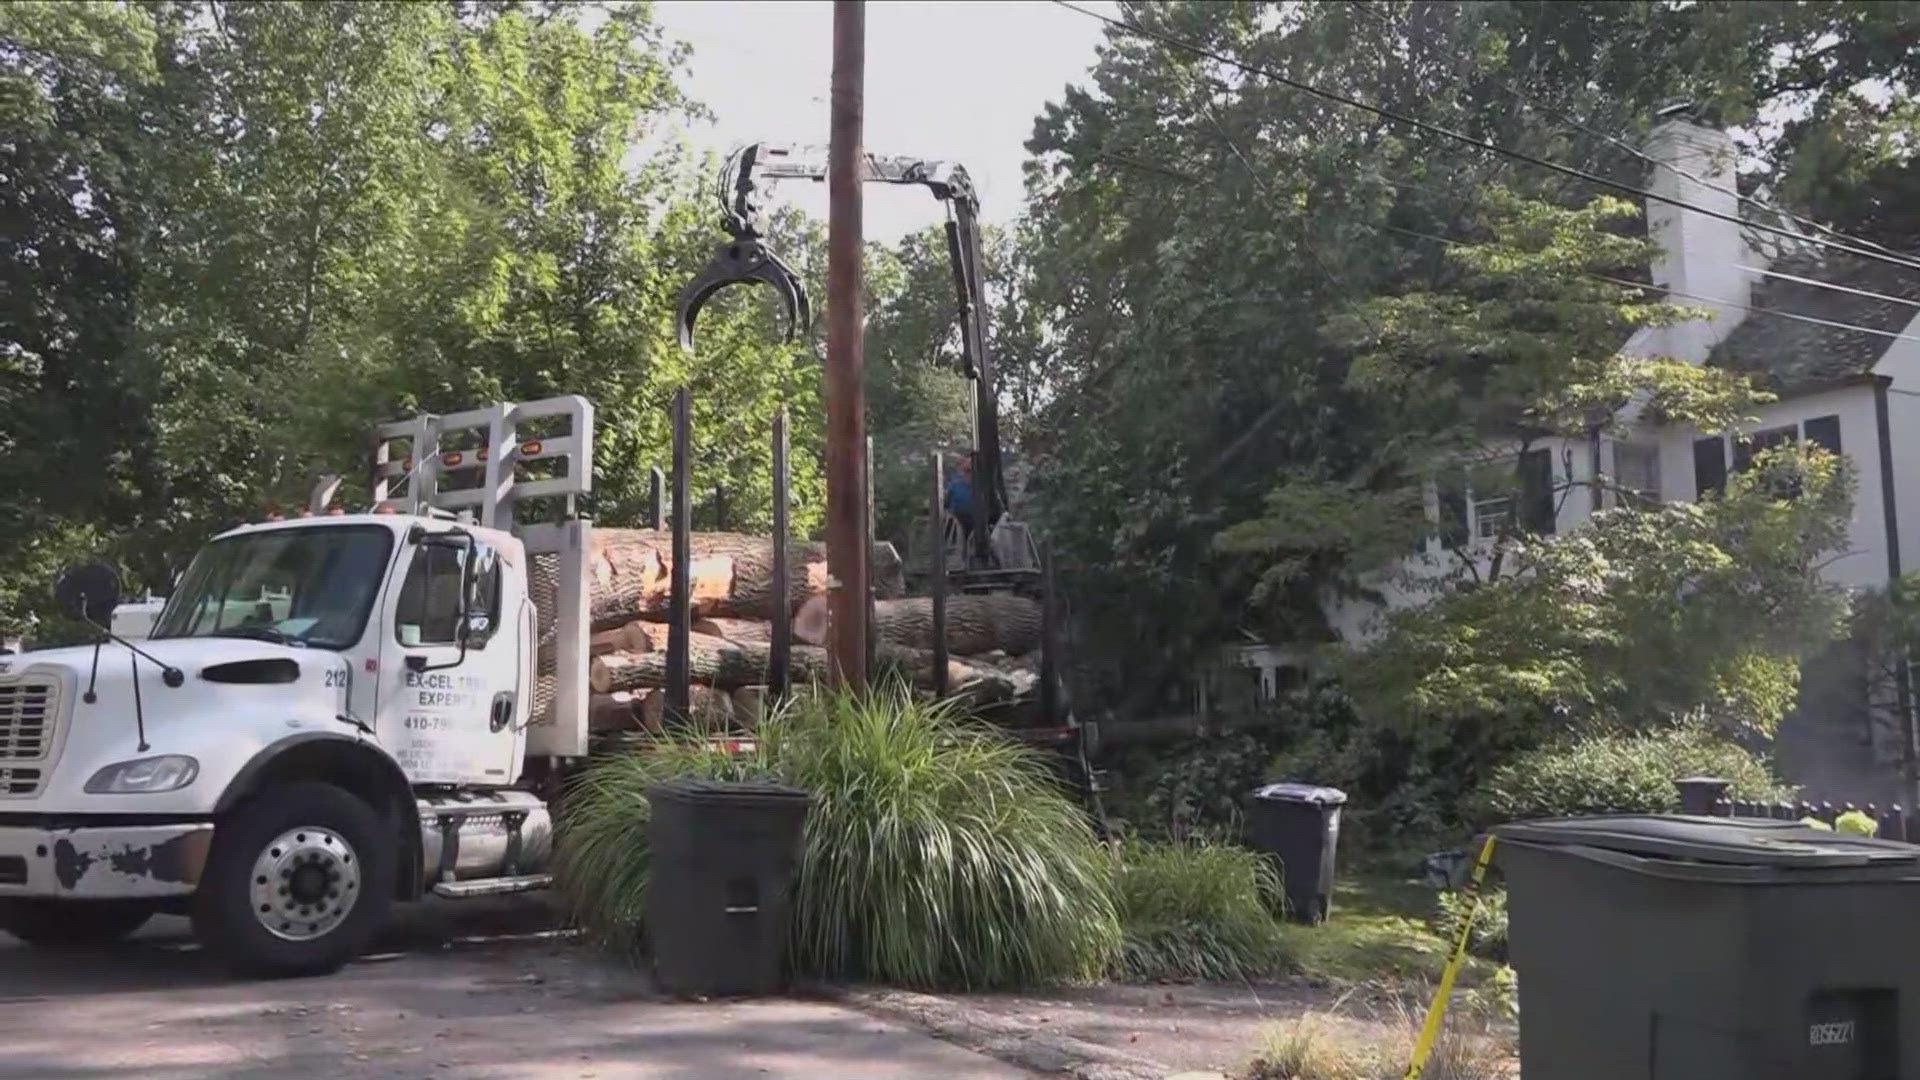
[{"x1": 372, "y1": 394, "x2": 593, "y2": 757}]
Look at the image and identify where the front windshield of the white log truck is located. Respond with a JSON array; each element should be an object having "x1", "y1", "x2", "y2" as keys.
[{"x1": 152, "y1": 525, "x2": 394, "y2": 650}]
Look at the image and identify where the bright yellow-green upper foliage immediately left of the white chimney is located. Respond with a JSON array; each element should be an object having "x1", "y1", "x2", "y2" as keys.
[{"x1": 1329, "y1": 184, "x2": 1763, "y2": 447}]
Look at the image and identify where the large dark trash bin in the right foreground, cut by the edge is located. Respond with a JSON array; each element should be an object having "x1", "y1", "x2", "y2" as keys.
[{"x1": 1494, "y1": 817, "x2": 1920, "y2": 1080}]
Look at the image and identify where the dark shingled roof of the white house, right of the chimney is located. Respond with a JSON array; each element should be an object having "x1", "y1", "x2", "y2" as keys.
[{"x1": 1707, "y1": 256, "x2": 1920, "y2": 392}]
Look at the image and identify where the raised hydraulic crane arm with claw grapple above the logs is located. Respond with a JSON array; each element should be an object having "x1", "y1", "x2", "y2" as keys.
[{"x1": 676, "y1": 142, "x2": 1006, "y2": 545}]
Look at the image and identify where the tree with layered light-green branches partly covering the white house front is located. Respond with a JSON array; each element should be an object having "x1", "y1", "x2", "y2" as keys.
[{"x1": 1217, "y1": 186, "x2": 1770, "y2": 590}]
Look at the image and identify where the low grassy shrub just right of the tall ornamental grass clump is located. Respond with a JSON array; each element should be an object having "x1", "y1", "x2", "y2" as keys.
[{"x1": 1114, "y1": 844, "x2": 1290, "y2": 982}]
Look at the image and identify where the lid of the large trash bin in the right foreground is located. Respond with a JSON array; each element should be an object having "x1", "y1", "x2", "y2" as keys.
[{"x1": 1494, "y1": 815, "x2": 1920, "y2": 871}]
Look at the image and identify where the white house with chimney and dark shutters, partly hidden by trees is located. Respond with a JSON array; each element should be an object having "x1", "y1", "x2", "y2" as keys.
[{"x1": 1329, "y1": 119, "x2": 1920, "y2": 799}]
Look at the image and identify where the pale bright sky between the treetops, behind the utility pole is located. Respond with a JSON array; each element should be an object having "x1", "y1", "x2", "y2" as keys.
[{"x1": 655, "y1": 0, "x2": 1116, "y2": 242}]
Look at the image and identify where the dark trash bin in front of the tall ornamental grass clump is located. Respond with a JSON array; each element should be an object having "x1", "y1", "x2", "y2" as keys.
[{"x1": 647, "y1": 780, "x2": 812, "y2": 995}]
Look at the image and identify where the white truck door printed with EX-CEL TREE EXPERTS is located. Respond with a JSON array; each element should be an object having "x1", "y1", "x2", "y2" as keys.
[{"x1": 374, "y1": 532, "x2": 532, "y2": 784}]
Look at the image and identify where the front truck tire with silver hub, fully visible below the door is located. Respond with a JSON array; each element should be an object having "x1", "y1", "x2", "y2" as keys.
[{"x1": 192, "y1": 782, "x2": 396, "y2": 978}]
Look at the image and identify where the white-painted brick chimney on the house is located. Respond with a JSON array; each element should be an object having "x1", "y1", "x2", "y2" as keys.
[{"x1": 1645, "y1": 117, "x2": 1764, "y2": 363}]
